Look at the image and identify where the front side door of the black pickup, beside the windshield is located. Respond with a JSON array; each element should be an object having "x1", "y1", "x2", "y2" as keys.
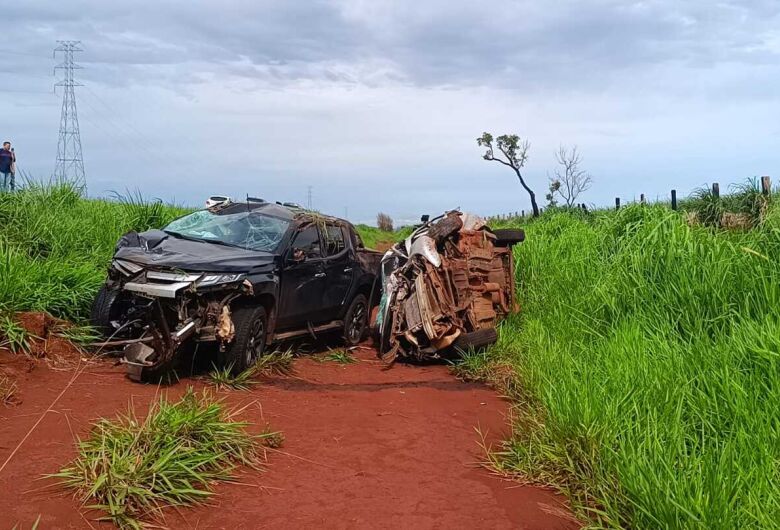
[{"x1": 278, "y1": 224, "x2": 326, "y2": 329}]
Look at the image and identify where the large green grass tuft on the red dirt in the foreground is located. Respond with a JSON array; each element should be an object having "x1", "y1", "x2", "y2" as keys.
[{"x1": 52, "y1": 388, "x2": 280, "y2": 529}]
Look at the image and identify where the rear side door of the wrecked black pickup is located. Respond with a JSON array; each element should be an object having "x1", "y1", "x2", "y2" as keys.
[{"x1": 322, "y1": 224, "x2": 358, "y2": 320}]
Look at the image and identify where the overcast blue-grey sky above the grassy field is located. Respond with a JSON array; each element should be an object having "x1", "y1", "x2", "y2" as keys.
[{"x1": 0, "y1": 0, "x2": 780, "y2": 221}]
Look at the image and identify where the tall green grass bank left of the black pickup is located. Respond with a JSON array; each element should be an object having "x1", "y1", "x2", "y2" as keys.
[{"x1": 0, "y1": 182, "x2": 187, "y2": 321}]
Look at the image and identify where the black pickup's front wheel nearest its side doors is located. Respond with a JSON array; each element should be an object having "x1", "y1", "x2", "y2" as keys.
[{"x1": 220, "y1": 306, "x2": 268, "y2": 374}]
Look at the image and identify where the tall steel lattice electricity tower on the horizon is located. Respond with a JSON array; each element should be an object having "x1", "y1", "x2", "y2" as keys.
[{"x1": 54, "y1": 40, "x2": 84, "y2": 183}]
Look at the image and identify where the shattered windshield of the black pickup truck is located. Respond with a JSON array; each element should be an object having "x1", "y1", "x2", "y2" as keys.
[{"x1": 164, "y1": 210, "x2": 290, "y2": 252}]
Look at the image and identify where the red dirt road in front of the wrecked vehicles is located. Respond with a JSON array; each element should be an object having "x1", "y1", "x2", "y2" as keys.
[{"x1": 0, "y1": 349, "x2": 579, "y2": 530}]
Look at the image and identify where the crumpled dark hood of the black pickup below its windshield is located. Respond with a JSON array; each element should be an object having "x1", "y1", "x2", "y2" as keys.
[{"x1": 114, "y1": 230, "x2": 274, "y2": 272}]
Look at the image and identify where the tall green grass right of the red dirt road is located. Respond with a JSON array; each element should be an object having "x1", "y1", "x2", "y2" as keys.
[{"x1": 482, "y1": 205, "x2": 780, "y2": 529}]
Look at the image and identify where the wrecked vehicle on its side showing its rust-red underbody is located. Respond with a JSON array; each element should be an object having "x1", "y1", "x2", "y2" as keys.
[{"x1": 375, "y1": 211, "x2": 525, "y2": 362}]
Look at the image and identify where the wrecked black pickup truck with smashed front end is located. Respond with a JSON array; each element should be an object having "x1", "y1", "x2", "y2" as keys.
[{"x1": 92, "y1": 199, "x2": 381, "y2": 381}]
